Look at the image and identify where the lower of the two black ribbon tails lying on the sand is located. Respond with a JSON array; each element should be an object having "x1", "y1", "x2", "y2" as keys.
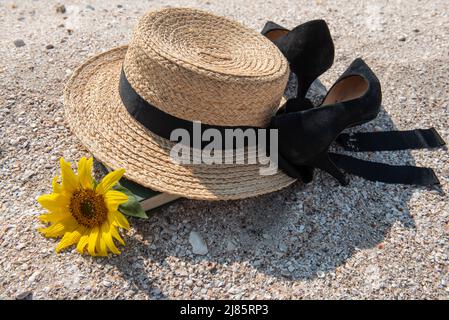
[{"x1": 329, "y1": 153, "x2": 440, "y2": 186}]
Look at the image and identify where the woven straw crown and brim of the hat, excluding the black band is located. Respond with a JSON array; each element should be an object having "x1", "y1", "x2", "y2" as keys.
[{"x1": 64, "y1": 8, "x2": 295, "y2": 200}]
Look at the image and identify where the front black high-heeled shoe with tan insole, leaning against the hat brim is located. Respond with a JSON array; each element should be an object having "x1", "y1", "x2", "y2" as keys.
[{"x1": 270, "y1": 59, "x2": 382, "y2": 185}]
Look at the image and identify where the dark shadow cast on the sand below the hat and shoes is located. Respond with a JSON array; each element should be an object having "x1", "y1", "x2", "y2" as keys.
[{"x1": 97, "y1": 75, "x2": 440, "y2": 299}]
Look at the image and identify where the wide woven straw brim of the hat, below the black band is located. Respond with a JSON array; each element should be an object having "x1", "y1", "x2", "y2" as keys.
[{"x1": 64, "y1": 46, "x2": 295, "y2": 200}]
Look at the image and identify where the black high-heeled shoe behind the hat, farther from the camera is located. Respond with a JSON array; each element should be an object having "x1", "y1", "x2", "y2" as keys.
[{"x1": 262, "y1": 20, "x2": 334, "y2": 98}]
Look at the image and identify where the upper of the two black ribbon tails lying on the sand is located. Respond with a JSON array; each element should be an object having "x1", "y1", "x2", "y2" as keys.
[{"x1": 336, "y1": 128, "x2": 446, "y2": 152}]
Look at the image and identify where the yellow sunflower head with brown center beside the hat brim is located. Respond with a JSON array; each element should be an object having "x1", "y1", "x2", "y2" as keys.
[{"x1": 37, "y1": 158, "x2": 129, "y2": 256}]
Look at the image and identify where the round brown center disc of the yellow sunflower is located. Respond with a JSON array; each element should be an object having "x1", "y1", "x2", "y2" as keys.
[{"x1": 70, "y1": 189, "x2": 108, "y2": 228}]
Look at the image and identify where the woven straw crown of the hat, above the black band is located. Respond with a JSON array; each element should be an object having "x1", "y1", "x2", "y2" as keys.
[{"x1": 124, "y1": 8, "x2": 289, "y2": 127}]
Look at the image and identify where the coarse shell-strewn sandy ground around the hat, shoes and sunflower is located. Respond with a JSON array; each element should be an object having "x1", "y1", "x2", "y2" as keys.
[{"x1": 0, "y1": 0, "x2": 449, "y2": 299}]
